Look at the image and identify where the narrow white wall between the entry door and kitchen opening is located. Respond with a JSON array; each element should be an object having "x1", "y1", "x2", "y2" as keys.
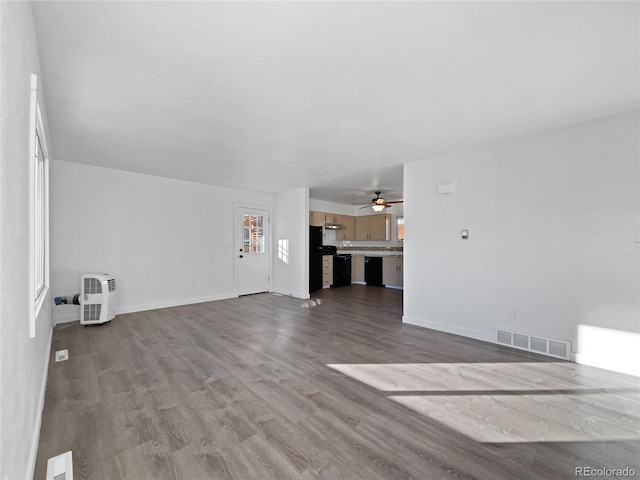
[{"x1": 272, "y1": 188, "x2": 309, "y2": 298}]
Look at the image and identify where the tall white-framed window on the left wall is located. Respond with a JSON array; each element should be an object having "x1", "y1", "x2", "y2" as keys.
[{"x1": 29, "y1": 75, "x2": 49, "y2": 337}]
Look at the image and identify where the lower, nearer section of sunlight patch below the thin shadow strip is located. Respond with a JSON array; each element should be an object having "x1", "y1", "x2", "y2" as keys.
[{"x1": 389, "y1": 393, "x2": 640, "y2": 443}]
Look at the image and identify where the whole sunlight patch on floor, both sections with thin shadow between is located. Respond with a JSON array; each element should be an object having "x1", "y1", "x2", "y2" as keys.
[{"x1": 327, "y1": 362, "x2": 640, "y2": 443}]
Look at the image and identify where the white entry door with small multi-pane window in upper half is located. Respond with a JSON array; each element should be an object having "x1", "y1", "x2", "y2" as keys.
[{"x1": 238, "y1": 208, "x2": 269, "y2": 295}]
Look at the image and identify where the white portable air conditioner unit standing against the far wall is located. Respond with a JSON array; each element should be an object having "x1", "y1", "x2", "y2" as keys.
[{"x1": 80, "y1": 273, "x2": 116, "y2": 325}]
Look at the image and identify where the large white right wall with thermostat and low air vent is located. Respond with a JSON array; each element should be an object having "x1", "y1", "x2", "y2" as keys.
[{"x1": 404, "y1": 111, "x2": 640, "y2": 374}]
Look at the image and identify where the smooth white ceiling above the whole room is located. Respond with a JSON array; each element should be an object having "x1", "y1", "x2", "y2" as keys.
[{"x1": 33, "y1": 1, "x2": 640, "y2": 203}]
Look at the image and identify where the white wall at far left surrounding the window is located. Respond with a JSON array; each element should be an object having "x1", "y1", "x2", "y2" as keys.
[{"x1": 0, "y1": 2, "x2": 52, "y2": 479}]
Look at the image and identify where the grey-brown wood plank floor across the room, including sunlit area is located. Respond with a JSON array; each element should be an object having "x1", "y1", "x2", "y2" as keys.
[{"x1": 35, "y1": 285, "x2": 640, "y2": 480}]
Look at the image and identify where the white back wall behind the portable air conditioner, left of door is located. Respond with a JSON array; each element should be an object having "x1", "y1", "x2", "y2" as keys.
[{"x1": 52, "y1": 160, "x2": 274, "y2": 321}]
